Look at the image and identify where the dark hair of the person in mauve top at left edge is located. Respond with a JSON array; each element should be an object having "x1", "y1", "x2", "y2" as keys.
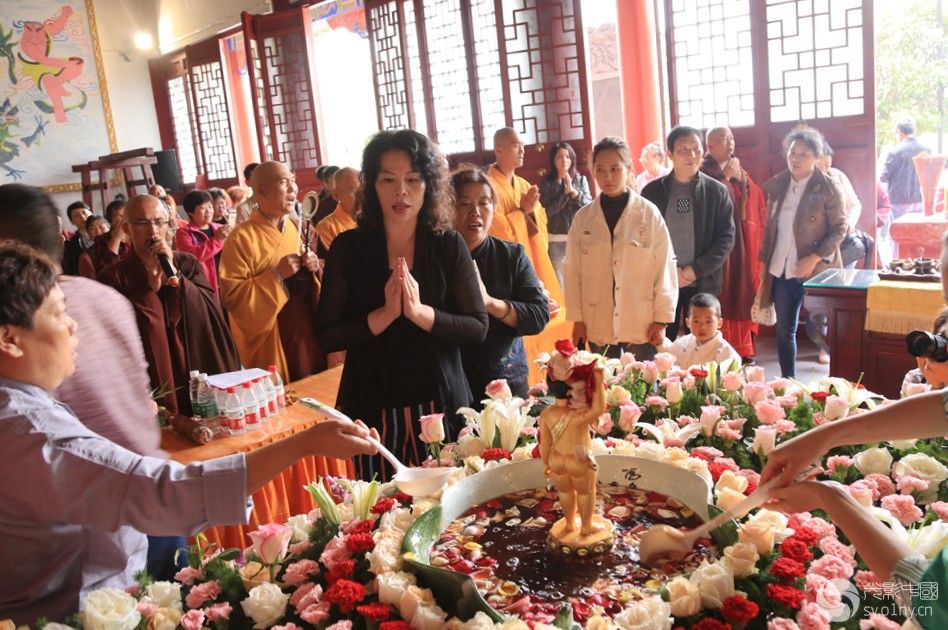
[{"x1": 0, "y1": 184, "x2": 63, "y2": 260}]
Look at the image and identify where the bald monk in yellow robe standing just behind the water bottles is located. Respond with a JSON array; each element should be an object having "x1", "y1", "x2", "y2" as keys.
[{"x1": 220, "y1": 162, "x2": 326, "y2": 382}]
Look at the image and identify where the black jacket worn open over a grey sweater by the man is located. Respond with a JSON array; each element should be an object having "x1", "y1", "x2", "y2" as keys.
[{"x1": 642, "y1": 171, "x2": 734, "y2": 295}]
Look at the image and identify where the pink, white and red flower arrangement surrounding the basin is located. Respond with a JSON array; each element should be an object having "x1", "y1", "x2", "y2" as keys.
[{"x1": 22, "y1": 354, "x2": 948, "y2": 630}]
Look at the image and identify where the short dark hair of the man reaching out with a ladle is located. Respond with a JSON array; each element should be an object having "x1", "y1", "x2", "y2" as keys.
[{"x1": 0, "y1": 241, "x2": 59, "y2": 330}]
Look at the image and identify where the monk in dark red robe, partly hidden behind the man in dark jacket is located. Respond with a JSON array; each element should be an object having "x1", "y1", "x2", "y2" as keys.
[{"x1": 701, "y1": 127, "x2": 767, "y2": 358}]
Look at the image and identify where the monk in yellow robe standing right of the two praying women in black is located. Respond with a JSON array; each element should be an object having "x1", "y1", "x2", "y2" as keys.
[{"x1": 487, "y1": 127, "x2": 572, "y2": 384}]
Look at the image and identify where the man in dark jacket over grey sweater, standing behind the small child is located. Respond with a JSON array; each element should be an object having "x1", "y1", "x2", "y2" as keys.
[{"x1": 642, "y1": 126, "x2": 734, "y2": 340}]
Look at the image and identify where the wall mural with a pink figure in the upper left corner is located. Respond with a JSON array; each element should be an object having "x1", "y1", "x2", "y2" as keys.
[{"x1": 0, "y1": 0, "x2": 116, "y2": 192}]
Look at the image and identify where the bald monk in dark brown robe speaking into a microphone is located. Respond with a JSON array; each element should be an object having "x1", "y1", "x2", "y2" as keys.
[{"x1": 99, "y1": 195, "x2": 240, "y2": 415}]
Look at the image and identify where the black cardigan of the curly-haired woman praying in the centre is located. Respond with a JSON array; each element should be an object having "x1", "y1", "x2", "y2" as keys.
[{"x1": 316, "y1": 227, "x2": 487, "y2": 426}]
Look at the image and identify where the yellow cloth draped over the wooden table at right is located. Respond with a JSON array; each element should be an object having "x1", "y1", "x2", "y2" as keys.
[{"x1": 866, "y1": 280, "x2": 945, "y2": 335}]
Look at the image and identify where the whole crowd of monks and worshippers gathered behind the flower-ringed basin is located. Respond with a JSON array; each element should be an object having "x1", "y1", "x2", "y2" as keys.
[{"x1": 0, "y1": 118, "x2": 936, "y2": 622}]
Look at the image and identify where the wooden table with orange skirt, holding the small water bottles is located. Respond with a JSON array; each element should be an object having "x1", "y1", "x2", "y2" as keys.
[{"x1": 161, "y1": 367, "x2": 354, "y2": 549}]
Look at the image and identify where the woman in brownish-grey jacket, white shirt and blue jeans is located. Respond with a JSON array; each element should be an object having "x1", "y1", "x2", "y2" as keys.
[{"x1": 760, "y1": 128, "x2": 846, "y2": 378}]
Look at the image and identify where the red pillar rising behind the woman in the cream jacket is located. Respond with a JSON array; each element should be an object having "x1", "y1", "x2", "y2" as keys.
[{"x1": 616, "y1": 0, "x2": 665, "y2": 160}]
